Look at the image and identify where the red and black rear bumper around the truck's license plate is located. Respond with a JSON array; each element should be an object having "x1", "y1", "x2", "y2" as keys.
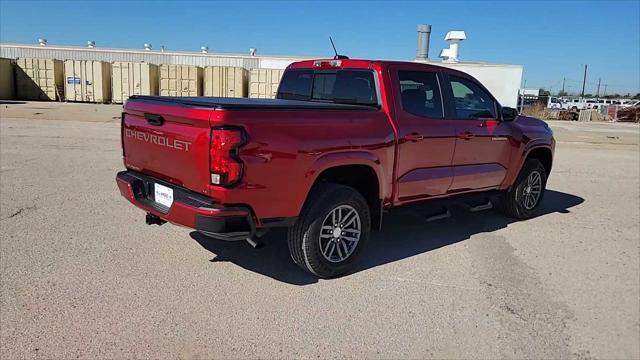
[{"x1": 116, "y1": 171, "x2": 256, "y2": 241}]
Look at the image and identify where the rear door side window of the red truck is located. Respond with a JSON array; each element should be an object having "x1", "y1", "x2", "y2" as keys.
[{"x1": 398, "y1": 71, "x2": 443, "y2": 119}]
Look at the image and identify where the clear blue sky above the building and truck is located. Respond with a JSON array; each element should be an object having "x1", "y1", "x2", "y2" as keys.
[{"x1": 0, "y1": 0, "x2": 640, "y2": 94}]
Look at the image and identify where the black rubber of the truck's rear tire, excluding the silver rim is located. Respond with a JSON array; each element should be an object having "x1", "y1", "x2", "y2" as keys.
[{"x1": 288, "y1": 183, "x2": 371, "y2": 279}]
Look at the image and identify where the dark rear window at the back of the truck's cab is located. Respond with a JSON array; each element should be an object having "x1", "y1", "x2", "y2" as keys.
[{"x1": 276, "y1": 70, "x2": 378, "y2": 106}]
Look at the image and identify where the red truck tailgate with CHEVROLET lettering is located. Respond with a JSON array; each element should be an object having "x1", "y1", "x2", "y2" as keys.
[{"x1": 122, "y1": 100, "x2": 214, "y2": 195}]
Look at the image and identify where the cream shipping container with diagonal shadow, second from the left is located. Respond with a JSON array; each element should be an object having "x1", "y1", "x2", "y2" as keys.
[{"x1": 15, "y1": 58, "x2": 64, "y2": 100}]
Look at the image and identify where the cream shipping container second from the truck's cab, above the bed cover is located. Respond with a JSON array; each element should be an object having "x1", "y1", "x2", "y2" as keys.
[{"x1": 204, "y1": 66, "x2": 249, "y2": 97}]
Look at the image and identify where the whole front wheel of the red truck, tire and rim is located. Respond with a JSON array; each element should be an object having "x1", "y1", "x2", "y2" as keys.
[{"x1": 500, "y1": 159, "x2": 547, "y2": 219}]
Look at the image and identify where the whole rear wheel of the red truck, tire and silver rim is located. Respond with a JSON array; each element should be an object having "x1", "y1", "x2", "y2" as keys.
[{"x1": 289, "y1": 184, "x2": 371, "y2": 278}]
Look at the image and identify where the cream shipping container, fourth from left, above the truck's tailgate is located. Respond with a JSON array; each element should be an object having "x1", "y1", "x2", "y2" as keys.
[{"x1": 111, "y1": 62, "x2": 159, "y2": 104}]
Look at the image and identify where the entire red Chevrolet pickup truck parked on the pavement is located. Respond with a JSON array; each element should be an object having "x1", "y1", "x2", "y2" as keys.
[{"x1": 116, "y1": 59, "x2": 555, "y2": 278}]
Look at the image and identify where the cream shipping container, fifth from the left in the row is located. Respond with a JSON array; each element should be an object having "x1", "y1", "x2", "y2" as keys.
[{"x1": 160, "y1": 64, "x2": 202, "y2": 96}]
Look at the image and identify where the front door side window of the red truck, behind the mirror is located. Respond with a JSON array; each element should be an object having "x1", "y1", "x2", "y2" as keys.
[{"x1": 449, "y1": 76, "x2": 497, "y2": 119}]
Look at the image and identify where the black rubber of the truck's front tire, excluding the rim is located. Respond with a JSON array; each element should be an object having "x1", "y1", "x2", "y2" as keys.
[{"x1": 500, "y1": 159, "x2": 547, "y2": 220}]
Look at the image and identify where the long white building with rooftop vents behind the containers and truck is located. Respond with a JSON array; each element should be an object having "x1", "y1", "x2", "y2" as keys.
[{"x1": 0, "y1": 25, "x2": 523, "y2": 107}]
